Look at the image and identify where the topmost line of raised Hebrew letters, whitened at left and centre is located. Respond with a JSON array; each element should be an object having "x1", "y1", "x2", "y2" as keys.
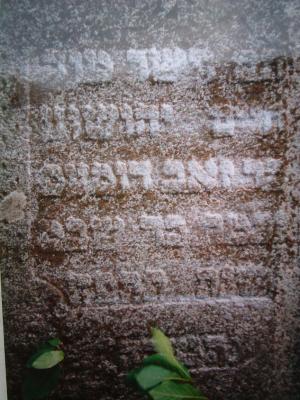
[{"x1": 18, "y1": 47, "x2": 282, "y2": 86}]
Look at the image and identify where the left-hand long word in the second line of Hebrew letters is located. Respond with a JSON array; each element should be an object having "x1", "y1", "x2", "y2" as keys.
[{"x1": 31, "y1": 100, "x2": 174, "y2": 142}]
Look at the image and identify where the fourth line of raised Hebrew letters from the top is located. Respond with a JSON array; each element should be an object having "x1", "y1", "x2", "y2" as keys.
[{"x1": 37, "y1": 205, "x2": 275, "y2": 252}]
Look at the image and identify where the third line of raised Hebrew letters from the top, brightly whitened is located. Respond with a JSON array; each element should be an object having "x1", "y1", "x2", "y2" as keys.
[{"x1": 37, "y1": 157, "x2": 281, "y2": 196}]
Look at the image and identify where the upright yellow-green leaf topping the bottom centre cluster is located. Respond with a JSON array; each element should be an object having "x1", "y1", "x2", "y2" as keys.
[{"x1": 151, "y1": 328, "x2": 191, "y2": 379}]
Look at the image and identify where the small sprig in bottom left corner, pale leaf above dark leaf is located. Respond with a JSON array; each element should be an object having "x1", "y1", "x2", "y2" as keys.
[{"x1": 22, "y1": 338, "x2": 65, "y2": 400}]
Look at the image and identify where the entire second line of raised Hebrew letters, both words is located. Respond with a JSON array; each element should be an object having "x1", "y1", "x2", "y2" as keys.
[{"x1": 31, "y1": 97, "x2": 283, "y2": 142}]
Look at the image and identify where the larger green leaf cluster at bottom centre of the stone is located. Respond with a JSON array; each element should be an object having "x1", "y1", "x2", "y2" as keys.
[{"x1": 128, "y1": 328, "x2": 207, "y2": 400}]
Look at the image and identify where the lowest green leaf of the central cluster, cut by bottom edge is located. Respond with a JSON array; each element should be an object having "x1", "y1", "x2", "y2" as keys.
[{"x1": 149, "y1": 381, "x2": 207, "y2": 400}]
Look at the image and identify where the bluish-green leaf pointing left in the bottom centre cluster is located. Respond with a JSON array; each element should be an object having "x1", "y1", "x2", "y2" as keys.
[{"x1": 135, "y1": 365, "x2": 180, "y2": 390}]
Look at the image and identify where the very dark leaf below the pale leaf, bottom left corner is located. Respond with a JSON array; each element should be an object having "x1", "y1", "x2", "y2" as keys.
[{"x1": 22, "y1": 365, "x2": 61, "y2": 400}]
